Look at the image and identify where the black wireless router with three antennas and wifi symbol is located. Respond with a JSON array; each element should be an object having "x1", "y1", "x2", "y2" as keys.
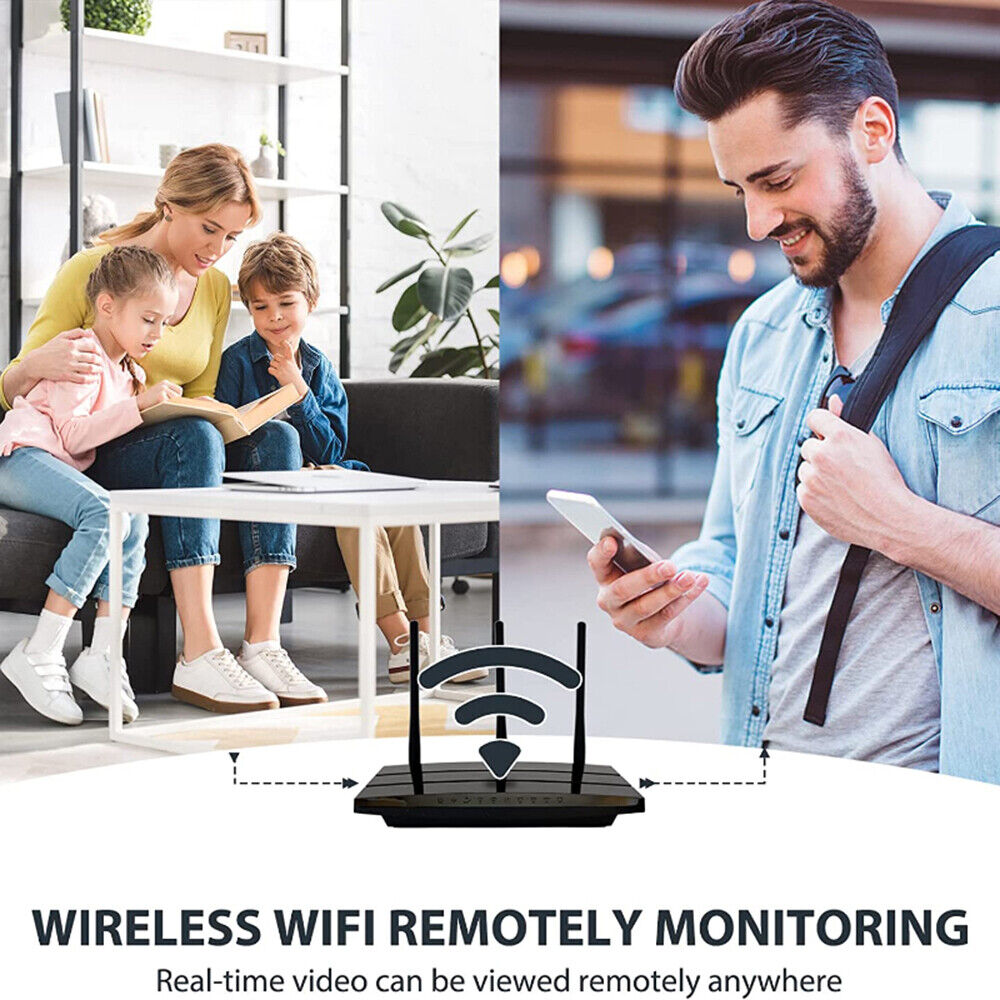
[{"x1": 354, "y1": 622, "x2": 645, "y2": 827}]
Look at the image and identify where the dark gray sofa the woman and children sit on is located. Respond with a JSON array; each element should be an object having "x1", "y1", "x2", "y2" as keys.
[{"x1": 0, "y1": 378, "x2": 499, "y2": 693}]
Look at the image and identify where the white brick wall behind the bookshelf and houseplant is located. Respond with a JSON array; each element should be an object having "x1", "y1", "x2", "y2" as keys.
[{"x1": 0, "y1": 0, "x2": 499, "y2": 377}]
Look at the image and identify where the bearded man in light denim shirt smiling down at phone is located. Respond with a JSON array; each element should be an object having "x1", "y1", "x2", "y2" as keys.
[{"x1": 588, "y1": 0, "x2": 1000, "y2": 782}]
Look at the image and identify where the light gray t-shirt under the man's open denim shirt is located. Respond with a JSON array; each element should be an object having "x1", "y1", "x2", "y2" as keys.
[{"x1": 764, "y1": 345, "x2": 941, "y2": 771}]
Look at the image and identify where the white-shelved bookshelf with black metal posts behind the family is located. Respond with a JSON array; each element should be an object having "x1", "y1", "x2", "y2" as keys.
[{"x1": 8, "y1": 0, "x2": 351, "y2": 378}]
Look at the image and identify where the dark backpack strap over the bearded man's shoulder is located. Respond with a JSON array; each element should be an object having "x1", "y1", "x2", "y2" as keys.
[{"x1": 802, "y1": 225, "x2": 1000, "y2": 726}]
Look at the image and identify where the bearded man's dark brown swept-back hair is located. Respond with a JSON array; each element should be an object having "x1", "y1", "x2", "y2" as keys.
[{"x1": 674, "y1": 0, "x2": 903, "y2": 160}]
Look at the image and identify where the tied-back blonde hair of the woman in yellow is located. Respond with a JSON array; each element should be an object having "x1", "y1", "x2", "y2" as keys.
[{"x1": 95, "y1": 142, "x2": 261, "y2": 243}]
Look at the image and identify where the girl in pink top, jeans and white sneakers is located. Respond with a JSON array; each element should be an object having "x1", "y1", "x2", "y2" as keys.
[{"x1": 0, "y1": 246, "x2": 181, "y2": 725}]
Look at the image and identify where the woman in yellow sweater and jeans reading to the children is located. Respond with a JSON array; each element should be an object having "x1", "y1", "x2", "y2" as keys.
[{"x1": 0, "y1": 144, "x2": 326, "y2": 712}]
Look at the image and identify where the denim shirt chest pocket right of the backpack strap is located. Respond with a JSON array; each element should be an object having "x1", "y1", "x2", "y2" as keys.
[{"x1": 918, "y1": 380, "x2": 1000, "y2": 523}]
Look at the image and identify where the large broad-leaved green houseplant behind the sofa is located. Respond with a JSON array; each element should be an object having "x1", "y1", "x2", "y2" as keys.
[{"x1": 375, "y1": 201, "x2": 500, "y2": 378}]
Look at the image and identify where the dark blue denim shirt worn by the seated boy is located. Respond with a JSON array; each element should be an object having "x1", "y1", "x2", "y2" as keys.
[{"x1": 215, "y1": 330, "x2": 368, "y2": 469}]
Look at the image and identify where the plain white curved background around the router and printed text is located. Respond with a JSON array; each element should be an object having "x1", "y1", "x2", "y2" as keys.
[{"x1": 0, "y1": 737, "x2": 1000, "y2": 1000}]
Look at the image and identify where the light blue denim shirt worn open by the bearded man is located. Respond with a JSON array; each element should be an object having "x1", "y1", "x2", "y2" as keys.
[{"x1": 674, "y1": 192, "x2": 1000, "y2": 783}]
